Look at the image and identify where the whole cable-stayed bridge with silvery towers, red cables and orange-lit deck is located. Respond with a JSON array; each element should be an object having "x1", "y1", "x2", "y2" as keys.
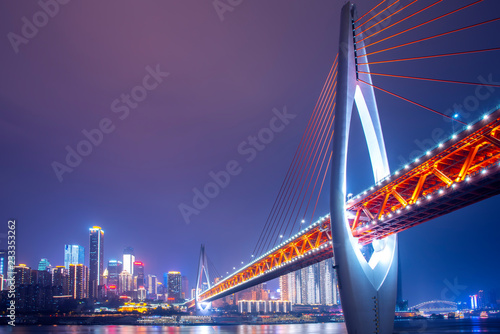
[{"x1": 188, "y1": 0, "x2": 500, "y2": 333}]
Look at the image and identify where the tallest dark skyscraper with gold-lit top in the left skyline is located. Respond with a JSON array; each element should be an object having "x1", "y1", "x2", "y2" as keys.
[{"x1": 89, "y1": 226, "x2": 104, "y2": 298}]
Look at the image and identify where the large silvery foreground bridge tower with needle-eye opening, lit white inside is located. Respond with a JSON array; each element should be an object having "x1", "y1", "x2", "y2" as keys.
[{"x1": 330, "y1": 1, "x2": 398, "y2": 334}]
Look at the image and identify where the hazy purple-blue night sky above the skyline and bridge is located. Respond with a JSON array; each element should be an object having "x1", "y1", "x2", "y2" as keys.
[{"x1": 0, "y1": 0, "x2": 500, "y2": 305}]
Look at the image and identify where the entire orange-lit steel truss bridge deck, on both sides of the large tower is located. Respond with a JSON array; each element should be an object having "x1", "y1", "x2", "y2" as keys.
[{"x1": 193, "y1": 109, "x2": 500, "y2": 306}]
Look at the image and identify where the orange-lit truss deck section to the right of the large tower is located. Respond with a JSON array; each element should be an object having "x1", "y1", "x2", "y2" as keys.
[{"x1": 347, "y1": 110, "x2": 500, "y2": 244}]
